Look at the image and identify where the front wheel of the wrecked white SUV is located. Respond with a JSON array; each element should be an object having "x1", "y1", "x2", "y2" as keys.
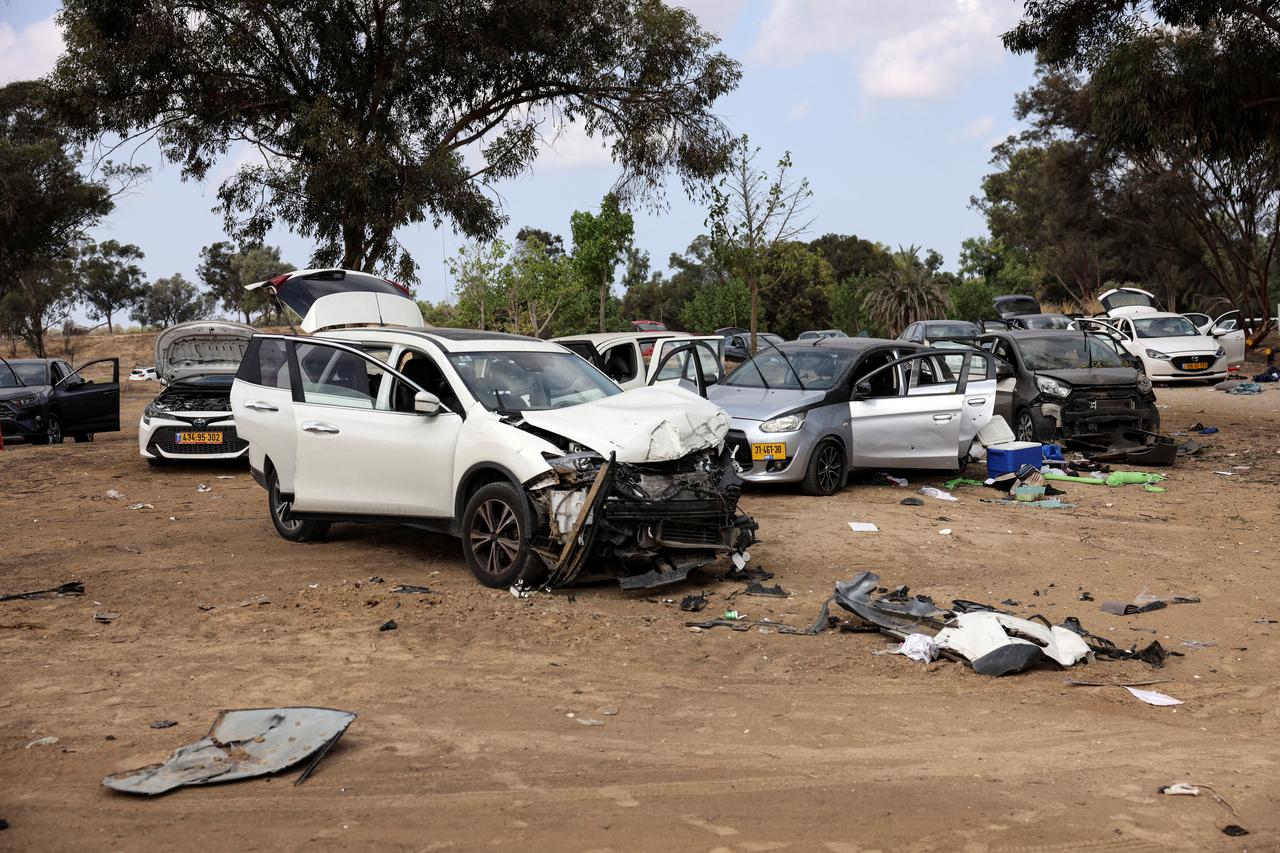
[{"x1": 462, "y1": 483, "x2": 538, "y2": 589}]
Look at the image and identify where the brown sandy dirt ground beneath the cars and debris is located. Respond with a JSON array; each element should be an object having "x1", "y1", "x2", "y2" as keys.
[{"x1": 0, "y1": 387, "x2": 1280, "y2": 853}]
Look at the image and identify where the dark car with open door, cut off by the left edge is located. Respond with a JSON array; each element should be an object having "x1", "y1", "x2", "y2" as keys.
[{"x1": 0, "y1": 359, "x2": 120, "y2": 444}]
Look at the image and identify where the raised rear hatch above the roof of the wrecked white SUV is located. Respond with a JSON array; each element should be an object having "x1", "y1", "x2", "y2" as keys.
[{"x1": 244, "y1": 269, "x2": 426, "y2": 333}]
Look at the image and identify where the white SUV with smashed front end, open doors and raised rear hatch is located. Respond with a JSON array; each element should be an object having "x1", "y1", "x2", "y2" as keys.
[{"x1": 232, "y1": 270, "x2": 755, "y2": 588}]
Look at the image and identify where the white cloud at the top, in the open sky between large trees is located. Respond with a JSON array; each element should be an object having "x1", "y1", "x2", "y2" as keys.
[{"x1": 751, "y1": 0, "x2": 1019, "y2": 100}]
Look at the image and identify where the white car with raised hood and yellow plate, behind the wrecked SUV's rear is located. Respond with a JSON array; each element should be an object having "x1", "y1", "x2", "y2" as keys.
[{"x1": 138, "y1": 320, "x2": 253, "y2": 465}]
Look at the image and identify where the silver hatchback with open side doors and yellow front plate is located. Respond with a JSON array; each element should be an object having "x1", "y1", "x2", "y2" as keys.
[{"x1": 708, "y1": 338, "x2": 996, "y2": 494}]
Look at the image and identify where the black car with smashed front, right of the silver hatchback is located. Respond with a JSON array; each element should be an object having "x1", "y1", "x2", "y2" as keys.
[{"x1": 980, "y1": 329, "x2": 1160, "y2": 442}]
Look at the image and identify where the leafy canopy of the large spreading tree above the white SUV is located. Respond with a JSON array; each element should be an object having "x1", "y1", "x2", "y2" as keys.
[{"x1": 52, "y1": 0, "x2": 741, "y2": 282}]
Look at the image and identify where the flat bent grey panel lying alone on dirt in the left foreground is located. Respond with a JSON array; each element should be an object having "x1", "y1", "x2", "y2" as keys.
[{"x1": 102, "y1": 708, "x2": 356, "y2": 795}]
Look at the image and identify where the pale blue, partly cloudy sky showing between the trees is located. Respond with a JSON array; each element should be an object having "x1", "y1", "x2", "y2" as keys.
[{"x1": 0, "y1": 0, "x2": 1033, "y2": 312}]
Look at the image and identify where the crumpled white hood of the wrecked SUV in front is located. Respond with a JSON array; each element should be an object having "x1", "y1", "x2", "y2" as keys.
[{"x1": 522, "y1": 386, "x2": 728, "y2": 462}]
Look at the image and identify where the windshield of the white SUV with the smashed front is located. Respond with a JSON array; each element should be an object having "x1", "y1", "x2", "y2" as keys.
[{"x1": 449, "y1": 351, "x2": 622, "y2": 412}]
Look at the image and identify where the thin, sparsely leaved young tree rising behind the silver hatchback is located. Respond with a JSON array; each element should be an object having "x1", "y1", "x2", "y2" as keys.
[{"x1": 707, "y1": 133, "x2": 813, "y2": 353}]
